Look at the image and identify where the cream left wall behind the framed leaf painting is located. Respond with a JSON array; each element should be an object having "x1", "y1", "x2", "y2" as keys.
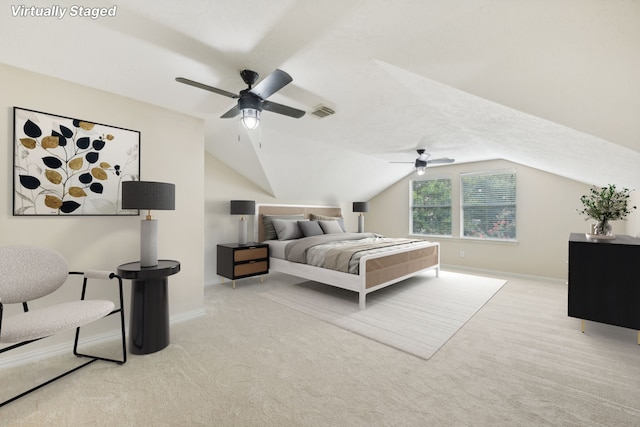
[{"x1": 0, "y1": 65, "x2": 204, "y2": 358}]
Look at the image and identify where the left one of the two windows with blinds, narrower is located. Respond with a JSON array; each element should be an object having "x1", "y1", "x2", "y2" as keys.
[{"x1": 409, "y1": 178, "x2": 451, "y2": 236}]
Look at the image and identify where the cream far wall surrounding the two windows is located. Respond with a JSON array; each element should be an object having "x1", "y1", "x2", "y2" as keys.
[{"x1": 366, "y1": 160, "x2": 640, "y2": 279}]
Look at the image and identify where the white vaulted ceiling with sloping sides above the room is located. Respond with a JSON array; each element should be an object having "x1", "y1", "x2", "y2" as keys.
[{"x1": 0, "y1": 0, "x2": 640, "y2": 201}]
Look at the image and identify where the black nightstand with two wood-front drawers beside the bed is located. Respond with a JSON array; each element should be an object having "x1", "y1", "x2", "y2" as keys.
[{"x1": 217, "y1": 243, "x2": 269, "y2": 289}]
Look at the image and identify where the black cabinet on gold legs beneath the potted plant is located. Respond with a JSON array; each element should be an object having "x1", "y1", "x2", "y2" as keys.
[{"x1": 568, "y1": 233, "x2": 640, "y2": 330}]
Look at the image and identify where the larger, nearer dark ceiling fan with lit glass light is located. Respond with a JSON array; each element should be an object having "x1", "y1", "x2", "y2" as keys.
[{"x1": 176, "y1": 69, "x2": 305, "y2": 130}]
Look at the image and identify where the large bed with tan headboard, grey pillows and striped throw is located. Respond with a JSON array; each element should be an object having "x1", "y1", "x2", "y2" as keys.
[{"x1": 254, "y1": 204, "x2": 440, "y2": 310}]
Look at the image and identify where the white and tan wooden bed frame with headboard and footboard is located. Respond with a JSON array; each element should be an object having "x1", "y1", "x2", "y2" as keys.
[{"x1": 254, "y1": 204, "x2": 440, "y2": 310}]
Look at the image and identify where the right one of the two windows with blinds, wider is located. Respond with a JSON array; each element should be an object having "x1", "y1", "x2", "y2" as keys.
[{"x1": 460, "y1": 171, "x2": 516, "y2": 240}]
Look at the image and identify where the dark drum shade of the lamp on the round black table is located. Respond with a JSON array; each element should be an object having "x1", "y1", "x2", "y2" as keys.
[{"x1": 122, "y1": 181, "x2": 176, "y2": 211}]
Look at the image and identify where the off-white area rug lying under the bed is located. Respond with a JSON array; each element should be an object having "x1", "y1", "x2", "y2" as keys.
[{"x1": 259, "y1": 271, "x2": 506, "y2": 359}]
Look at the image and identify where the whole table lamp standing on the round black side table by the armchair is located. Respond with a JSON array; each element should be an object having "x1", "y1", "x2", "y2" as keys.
[{"x1": 122, "y1": 181, "x2": 176, "y2": 267}]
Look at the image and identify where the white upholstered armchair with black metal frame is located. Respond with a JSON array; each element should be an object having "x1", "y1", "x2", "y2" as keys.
[{"x1": 0, "y1": 245, "x2": 127, "y2": 407}]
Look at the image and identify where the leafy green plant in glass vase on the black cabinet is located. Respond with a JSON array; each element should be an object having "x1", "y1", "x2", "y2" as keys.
[{"x1": 578, "y1": 184, "x2": 636, "y2": 236}]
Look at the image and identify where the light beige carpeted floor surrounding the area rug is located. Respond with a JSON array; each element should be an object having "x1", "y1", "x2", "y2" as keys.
[{"x1": 0, "y1": 274, "x2": 640, "y2": 427}]
